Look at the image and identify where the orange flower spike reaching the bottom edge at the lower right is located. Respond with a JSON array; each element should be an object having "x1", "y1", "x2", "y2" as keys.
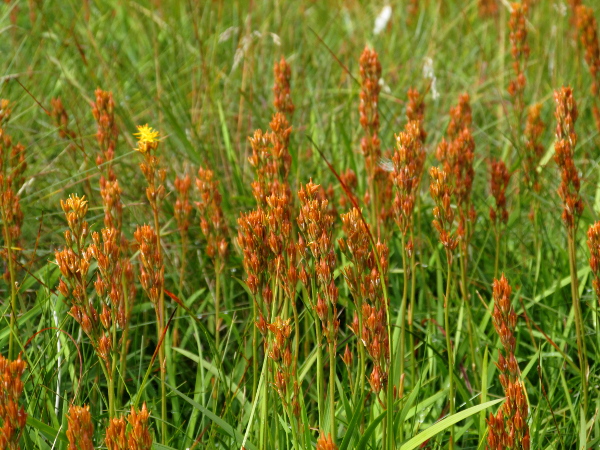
[{"x1": 487, "y1": 275, "x2": 530, "y2": 450}]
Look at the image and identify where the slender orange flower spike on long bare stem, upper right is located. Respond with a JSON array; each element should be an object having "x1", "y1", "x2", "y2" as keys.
[{"x1": 554, "y1": 87, "x2": 583, "y2": 229}]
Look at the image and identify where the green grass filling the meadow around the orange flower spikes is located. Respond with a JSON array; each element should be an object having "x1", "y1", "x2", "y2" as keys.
[{"x1": 0, "y1": 0, "x2": 600, "y2": 449}]
